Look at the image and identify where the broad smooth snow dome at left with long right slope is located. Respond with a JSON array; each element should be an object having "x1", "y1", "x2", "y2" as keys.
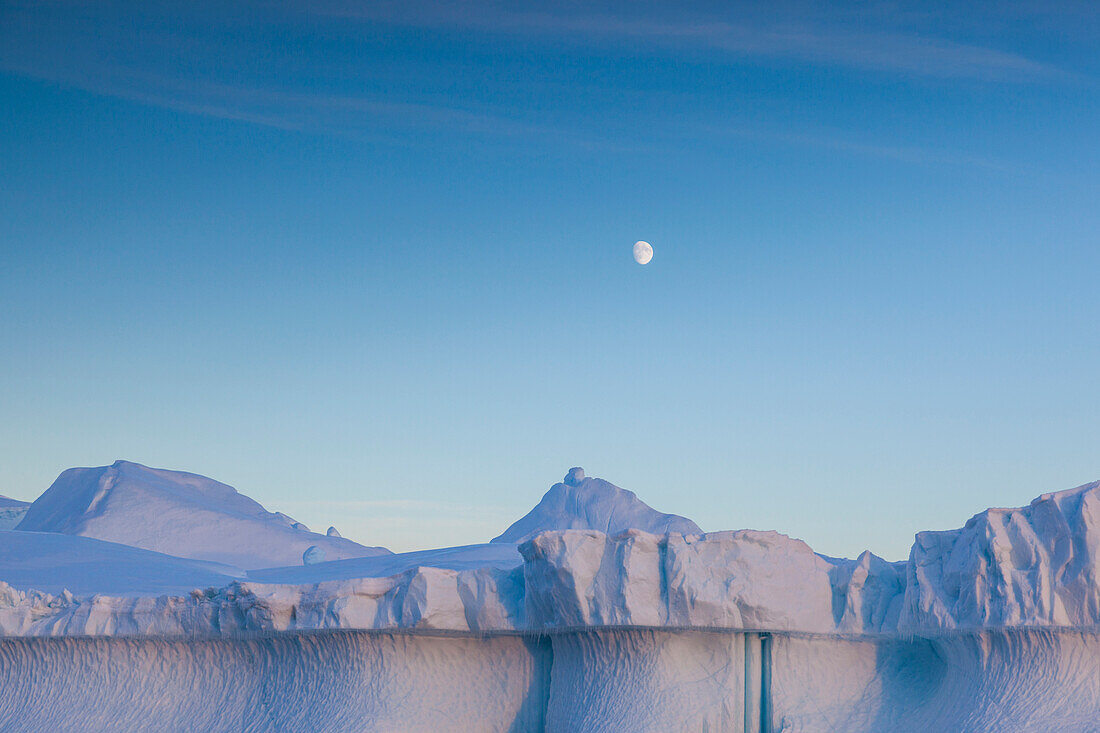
[{"x1": 18, "y1": 461, "x2": 389, "y2": 569}]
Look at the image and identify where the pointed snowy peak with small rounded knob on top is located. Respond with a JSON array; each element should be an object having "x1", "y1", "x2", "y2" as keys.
[{"x1": 493, "y1": 467, "x2": 703, "y2": 543}]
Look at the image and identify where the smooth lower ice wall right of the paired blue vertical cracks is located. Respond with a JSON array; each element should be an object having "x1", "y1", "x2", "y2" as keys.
[{"x1": 770, "y1": 630, "x2": 1100, "y2": 733}]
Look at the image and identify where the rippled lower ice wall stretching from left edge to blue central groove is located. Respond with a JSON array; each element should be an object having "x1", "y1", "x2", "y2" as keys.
[{"x1": 0, "y1": 633, "x2": 551, "y2": 733}]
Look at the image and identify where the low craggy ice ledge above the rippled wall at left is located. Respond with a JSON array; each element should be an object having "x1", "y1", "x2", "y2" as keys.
[{"x1": 0, "y1": 559, "x2": 526, "y2": 638}]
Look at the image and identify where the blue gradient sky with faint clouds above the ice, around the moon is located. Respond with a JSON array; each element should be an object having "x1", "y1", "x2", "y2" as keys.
[{"x1": 0, "y1": 1, "x2": 1100, "y2": 559}]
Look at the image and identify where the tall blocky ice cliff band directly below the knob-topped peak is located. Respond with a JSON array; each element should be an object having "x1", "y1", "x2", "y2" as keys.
[{"x1": 520, "y1": 529, "x2": 904, "y2": 633}]
